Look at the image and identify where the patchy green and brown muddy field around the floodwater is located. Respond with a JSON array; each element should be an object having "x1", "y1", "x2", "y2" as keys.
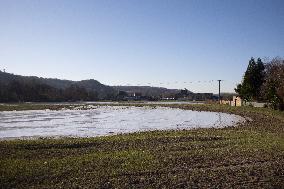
[{"x1": 0, "y1": 105, "x2": 284, "y2": 188}]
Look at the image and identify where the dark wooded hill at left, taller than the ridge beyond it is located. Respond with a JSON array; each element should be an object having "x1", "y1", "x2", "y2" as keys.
[{"x1": 0, "y1": 71, "x2": 117, "y2": 102}]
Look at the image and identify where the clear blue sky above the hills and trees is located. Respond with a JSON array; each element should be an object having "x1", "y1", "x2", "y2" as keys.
[{"x1": 0, "y1": 0, "x2": 284, "y2": 93}]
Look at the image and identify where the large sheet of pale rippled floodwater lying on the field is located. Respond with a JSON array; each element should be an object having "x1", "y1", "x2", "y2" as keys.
[{"x1": 0, "y1": 105, "x2": 245, "y2": 140}]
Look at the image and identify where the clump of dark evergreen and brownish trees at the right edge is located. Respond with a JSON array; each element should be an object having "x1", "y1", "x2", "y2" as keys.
[{"x1": 235, "y1": 57, "x2": 284, "y2": 110}]
